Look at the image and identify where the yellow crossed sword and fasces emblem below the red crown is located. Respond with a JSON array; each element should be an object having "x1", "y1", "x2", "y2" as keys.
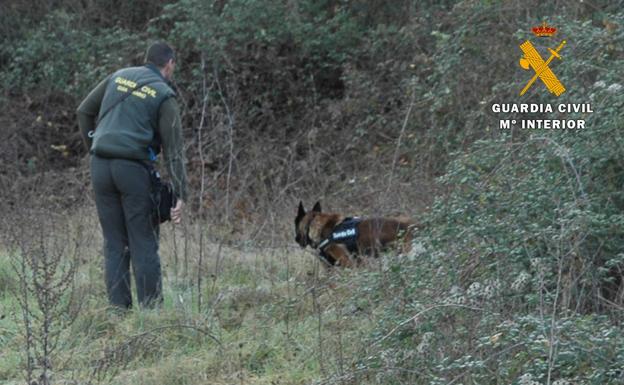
[{"x1": 520, "y1": 40, "x2": 566, "y2": 96}]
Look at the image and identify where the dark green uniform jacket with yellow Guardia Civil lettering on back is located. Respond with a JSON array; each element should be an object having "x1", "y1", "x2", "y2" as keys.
[{"x1": 77, "y1": 64, "x2": 187, "y2": 201}]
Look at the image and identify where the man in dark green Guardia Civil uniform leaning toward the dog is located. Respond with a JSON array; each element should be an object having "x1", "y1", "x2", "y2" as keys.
[{"x1": 77, "y1": 42, "x2": 187, "y2": 308}]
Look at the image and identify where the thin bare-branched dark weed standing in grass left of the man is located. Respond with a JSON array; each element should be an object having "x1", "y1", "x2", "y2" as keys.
[{"x1": 3, "y1": 195, "x2": 86, "y2": 385}]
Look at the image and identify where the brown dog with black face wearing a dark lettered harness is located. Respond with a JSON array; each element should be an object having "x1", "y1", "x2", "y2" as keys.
[{"x1": 295, "y1": 202, "x2": 413, "y2": 267}]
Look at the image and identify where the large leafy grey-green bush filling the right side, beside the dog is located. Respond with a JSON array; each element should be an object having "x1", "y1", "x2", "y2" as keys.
[{"x1": 346, "y1": 10, "x2": 624, "y2": 385}]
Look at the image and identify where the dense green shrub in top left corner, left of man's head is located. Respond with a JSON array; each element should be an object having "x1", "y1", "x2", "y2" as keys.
[{"x1": 0, "y1": 11, "x2": 140, "y2": 95}]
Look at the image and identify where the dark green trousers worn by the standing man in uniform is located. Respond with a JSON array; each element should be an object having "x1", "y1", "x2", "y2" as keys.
[{"x1": 91, "y1": 155, "x2": 162, "y2": 308}]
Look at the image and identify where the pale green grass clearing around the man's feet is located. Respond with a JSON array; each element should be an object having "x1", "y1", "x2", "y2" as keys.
[{"x1": 0, "y1": 212, "x2": 380, "y2": 385}]
